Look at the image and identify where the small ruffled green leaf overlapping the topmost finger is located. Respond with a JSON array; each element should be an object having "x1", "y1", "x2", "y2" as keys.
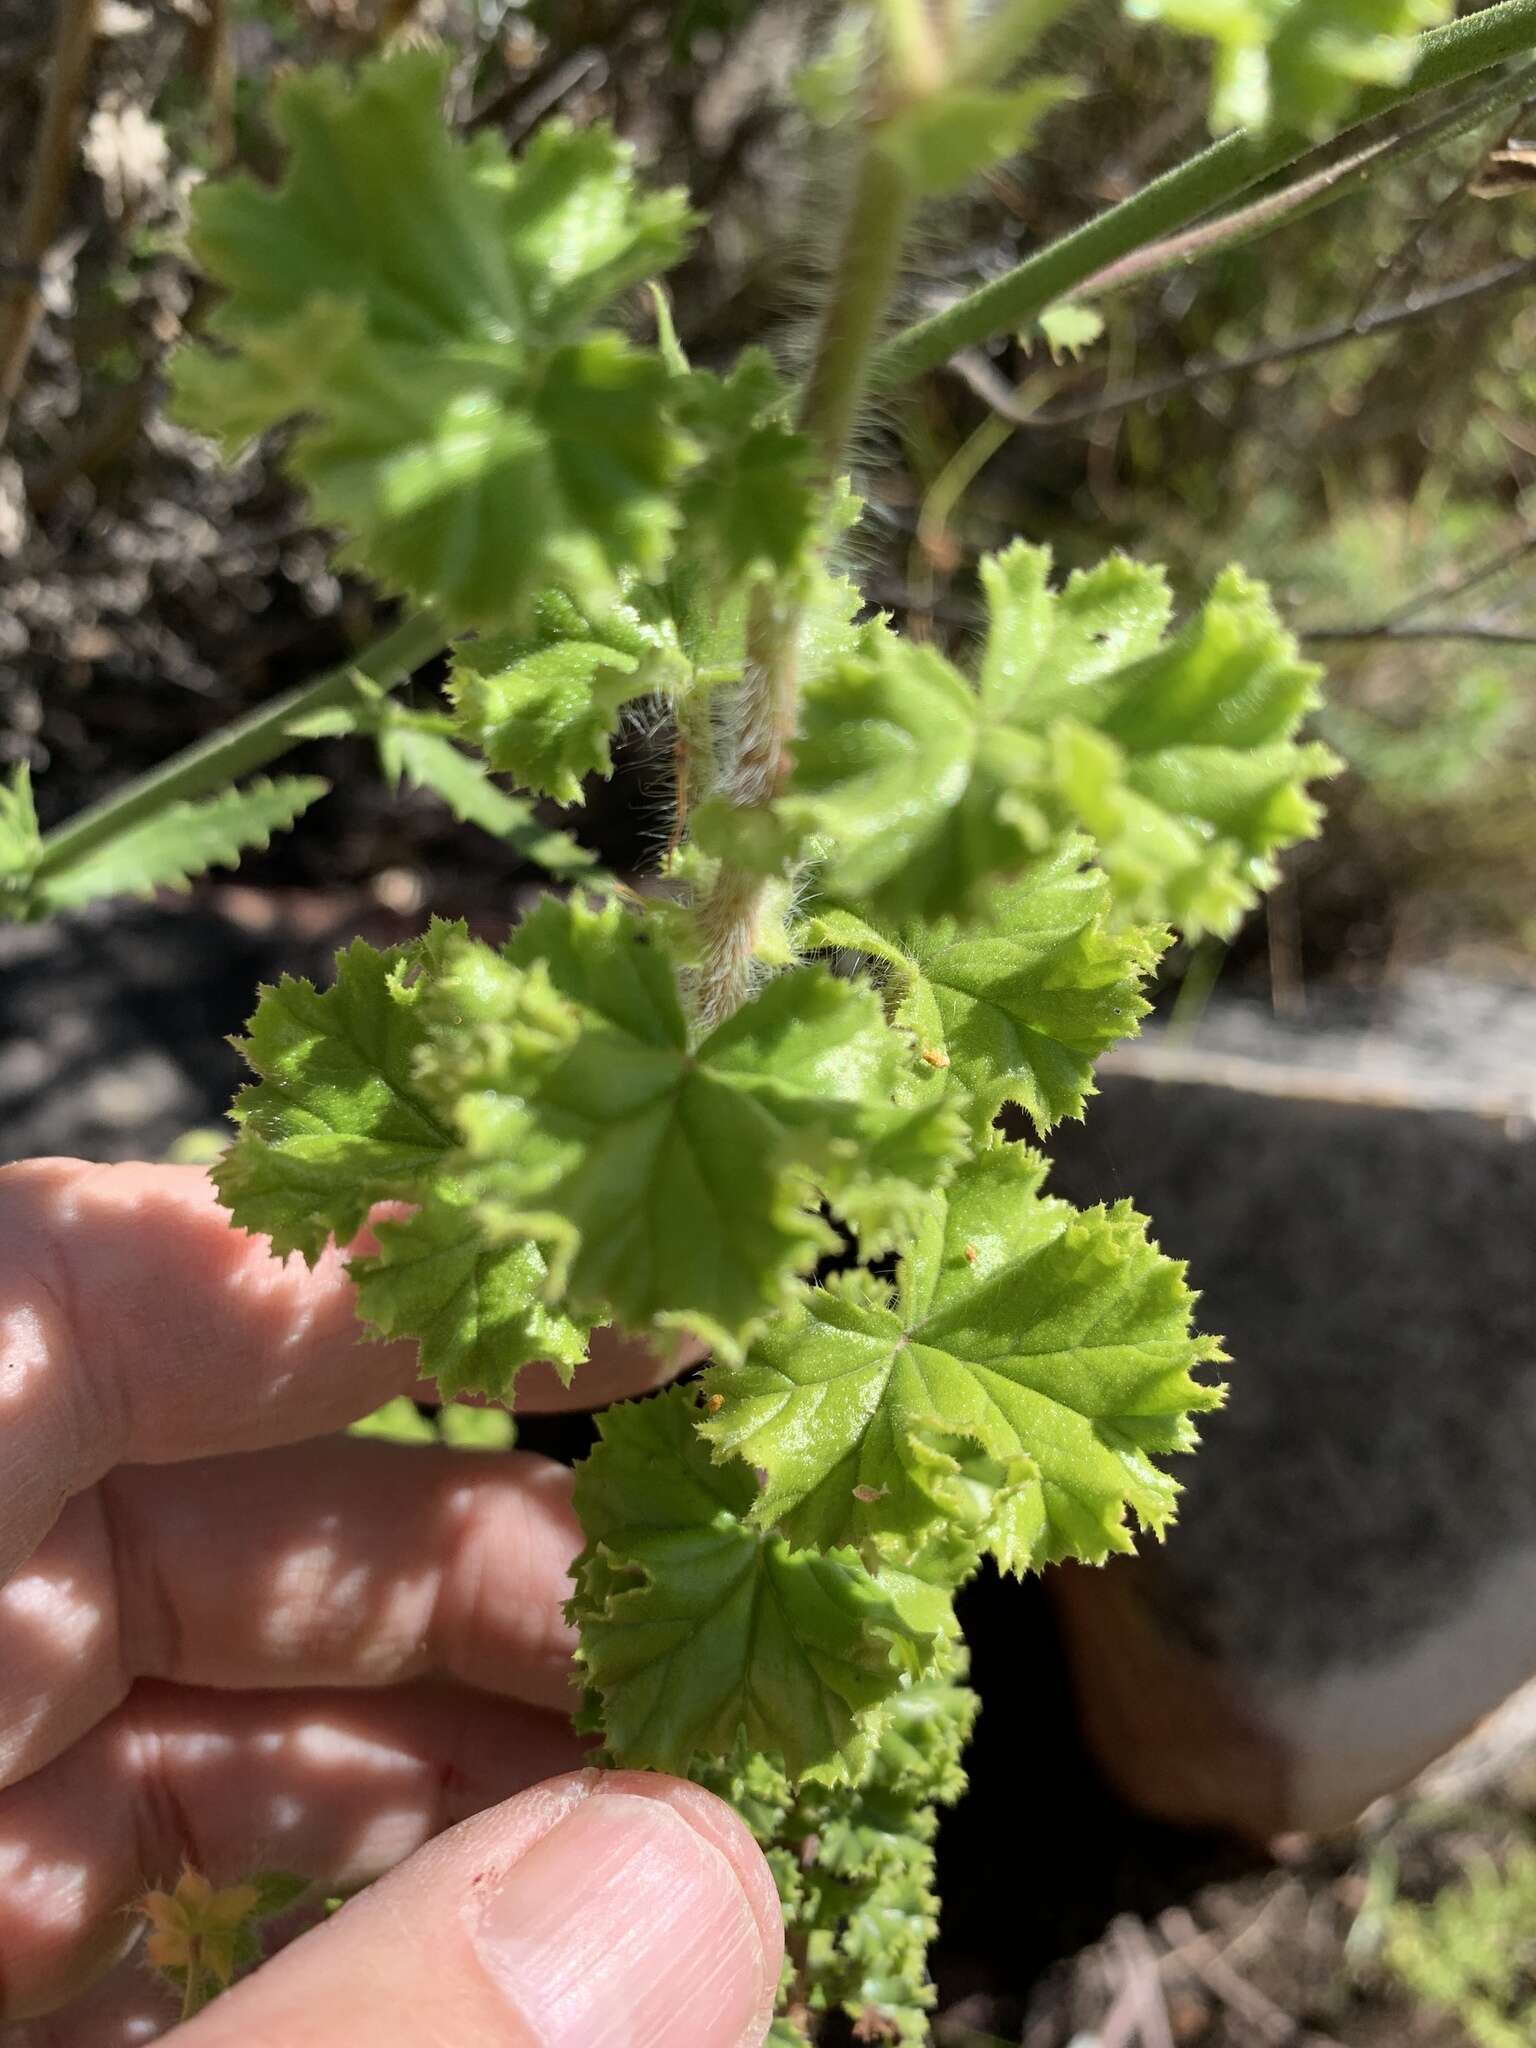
[{"x1": 352, "y1": 1178, "x2": 590, "y2": 1399}]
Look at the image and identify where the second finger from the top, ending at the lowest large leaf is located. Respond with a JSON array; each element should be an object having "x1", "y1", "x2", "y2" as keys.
[{"x1": 0, "y1": 1438, "x2": 582, "y2": 1786}]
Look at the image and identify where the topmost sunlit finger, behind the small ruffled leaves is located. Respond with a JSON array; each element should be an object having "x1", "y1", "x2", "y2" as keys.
[{"x1": 0, "y1": 1159, "x2": 416, "y2": 1577}]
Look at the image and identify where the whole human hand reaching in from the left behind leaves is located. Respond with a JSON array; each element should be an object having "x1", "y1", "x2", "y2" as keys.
[{"x1": 0, "y1": 1159, "x2": 782, "y2": 2048}]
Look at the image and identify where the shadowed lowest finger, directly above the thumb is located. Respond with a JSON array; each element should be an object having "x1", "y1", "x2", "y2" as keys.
[{"x1": 0, "y1": 1683, "x2": 582, "y2": 2019}]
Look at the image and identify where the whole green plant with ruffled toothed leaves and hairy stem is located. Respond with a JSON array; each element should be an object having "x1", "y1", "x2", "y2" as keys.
[{"x1": 18, "y1": 0, "x2": 1536, "y2": 2042}]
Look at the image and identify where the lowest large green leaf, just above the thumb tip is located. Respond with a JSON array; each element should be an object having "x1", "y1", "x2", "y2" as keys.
[{"x1": 571, "y1": 1389, "x2": 934, "y2": 1778}]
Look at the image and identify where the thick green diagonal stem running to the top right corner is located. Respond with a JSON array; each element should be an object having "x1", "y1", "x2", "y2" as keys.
[{"x1": 872, "y1": 0, "x2": 1536, "y2": 389}]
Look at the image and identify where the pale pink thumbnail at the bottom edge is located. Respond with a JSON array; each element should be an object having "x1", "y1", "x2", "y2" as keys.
[{"x1": 475, "y1": 1788, "x2": 772, "y2": 2048}]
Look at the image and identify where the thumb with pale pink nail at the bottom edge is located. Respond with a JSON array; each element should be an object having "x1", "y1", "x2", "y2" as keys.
[{"x1": 178, "y1": 1769, "x2": 782, "y2": 2048}]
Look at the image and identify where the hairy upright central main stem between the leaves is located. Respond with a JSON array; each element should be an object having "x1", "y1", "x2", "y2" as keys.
[{"x1": 698, "y1": 125, "x2": 913, "y2": 1030}]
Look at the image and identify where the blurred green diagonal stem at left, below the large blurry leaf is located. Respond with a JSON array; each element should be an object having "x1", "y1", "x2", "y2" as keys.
[{"x1": 35, "y1": 610, "x2": 446, "y2": 881}]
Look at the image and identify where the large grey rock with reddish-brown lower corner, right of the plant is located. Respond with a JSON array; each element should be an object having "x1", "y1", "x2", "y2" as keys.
[{"x1": 1049, "y1": 977, "x2": 1536, "y2": 1839}]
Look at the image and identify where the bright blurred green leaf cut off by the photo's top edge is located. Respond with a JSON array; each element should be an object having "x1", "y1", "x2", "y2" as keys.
[{"x1": 1126, "y1": 0, "x2": 1456, "y2": 133}]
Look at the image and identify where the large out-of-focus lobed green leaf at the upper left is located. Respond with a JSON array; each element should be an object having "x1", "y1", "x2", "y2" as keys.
[{"x1": 174, "y1": 51, "x2": 690, "y2": 627}]
